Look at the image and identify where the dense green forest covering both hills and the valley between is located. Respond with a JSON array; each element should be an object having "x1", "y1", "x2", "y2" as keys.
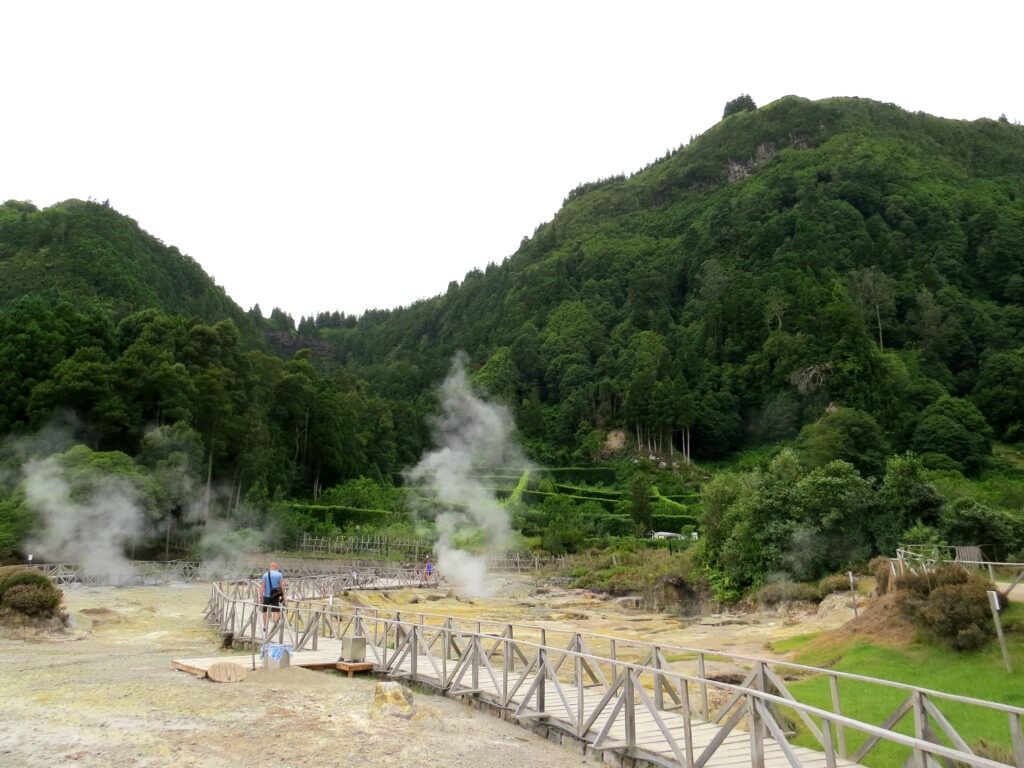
[{"x1": 0, "y1": 96, "x2": 1024, "y2": 592}]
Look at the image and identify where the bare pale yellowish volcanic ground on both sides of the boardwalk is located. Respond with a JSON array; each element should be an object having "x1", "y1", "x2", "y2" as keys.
[{"x1": 0, "y1": 581, "x2": 856, "y2": 768}]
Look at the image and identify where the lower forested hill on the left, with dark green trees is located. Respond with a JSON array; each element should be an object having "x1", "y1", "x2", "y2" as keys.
[{"x1": 0, "y1": 200, "x2": 422, "y2": 512}]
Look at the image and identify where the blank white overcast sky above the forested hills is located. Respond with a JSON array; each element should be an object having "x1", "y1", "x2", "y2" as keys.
[{"x1": 0, "y1": 0, "x2": 1024, "y2": 322}]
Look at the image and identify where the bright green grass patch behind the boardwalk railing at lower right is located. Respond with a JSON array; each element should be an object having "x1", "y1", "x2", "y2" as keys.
[{"x1": 774, "y1": 604, "x2": 1024, "y2": 768}]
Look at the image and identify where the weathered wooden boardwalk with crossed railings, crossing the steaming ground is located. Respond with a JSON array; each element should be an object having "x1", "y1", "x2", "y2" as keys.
[{"x1": 174, "y1": 573, "x2": 1024, "y2": 768}]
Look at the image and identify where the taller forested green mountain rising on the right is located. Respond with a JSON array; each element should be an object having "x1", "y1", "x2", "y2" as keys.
[{"x1": 315, "y1": 97, "x2": 1024, "y2": 464}]
